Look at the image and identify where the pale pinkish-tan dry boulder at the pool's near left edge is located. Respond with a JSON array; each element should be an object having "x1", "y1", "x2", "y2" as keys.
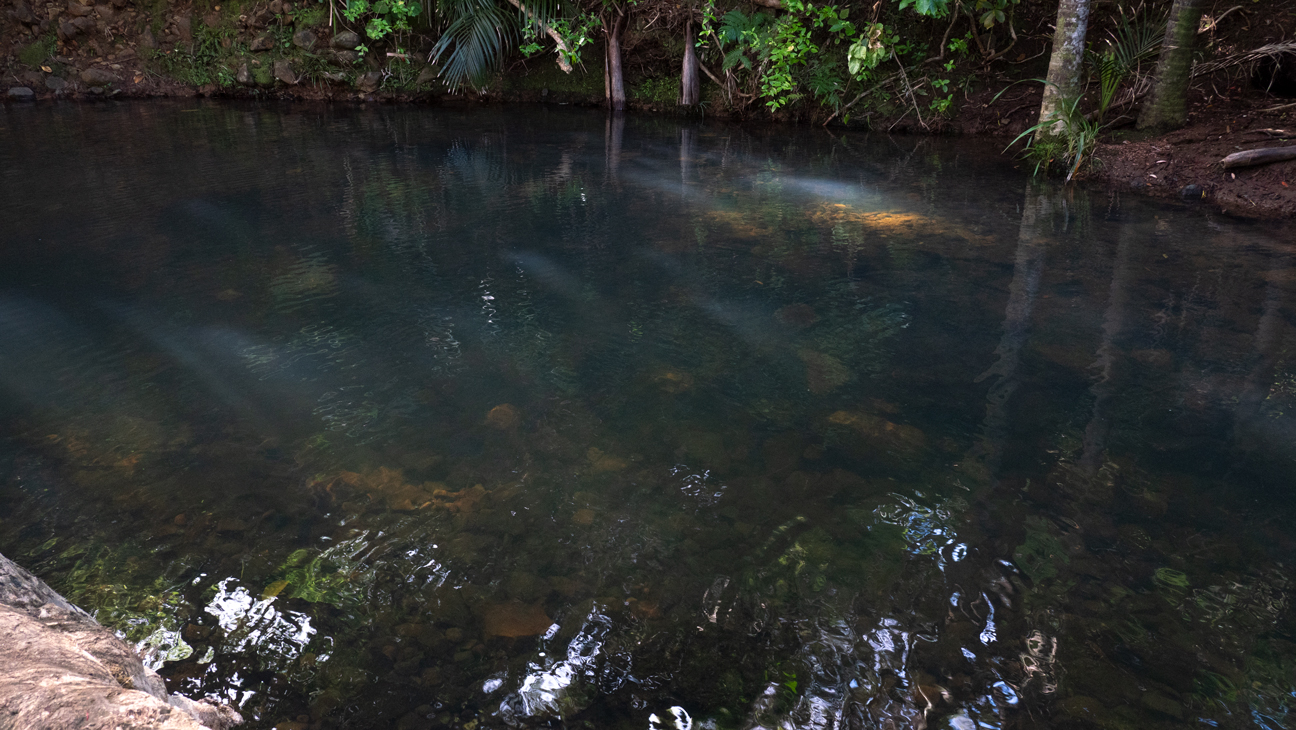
[{"x1": 0, "y1": 555, "x2": 242, "y2": 730}]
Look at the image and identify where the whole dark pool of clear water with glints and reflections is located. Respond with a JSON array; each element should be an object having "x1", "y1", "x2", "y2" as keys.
[{"x1": 0, "y1": 102, "x2": 1296, "y2": 730}]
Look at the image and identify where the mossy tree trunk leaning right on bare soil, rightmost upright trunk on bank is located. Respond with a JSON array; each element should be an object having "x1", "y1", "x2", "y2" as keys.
[{"x1": 1138, "y1": 0, "x2": 1205, "y2": 131}]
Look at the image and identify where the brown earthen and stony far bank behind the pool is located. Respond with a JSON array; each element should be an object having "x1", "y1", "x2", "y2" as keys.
[{"x1": 0, "y1": 0, "x2": 1296, "y2": 219}]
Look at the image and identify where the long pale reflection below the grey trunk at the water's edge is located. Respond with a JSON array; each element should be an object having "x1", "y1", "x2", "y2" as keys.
[{"x1": 976, "y1": 183, "x2": 1055, "y2": 478}]
